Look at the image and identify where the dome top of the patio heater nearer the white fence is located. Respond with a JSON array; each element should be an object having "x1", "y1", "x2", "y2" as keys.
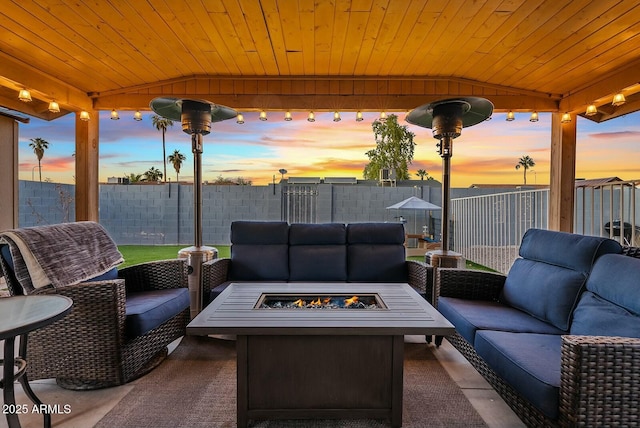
[{"x1": 406, "y1": 97, "x2": 493, "y2": 128}]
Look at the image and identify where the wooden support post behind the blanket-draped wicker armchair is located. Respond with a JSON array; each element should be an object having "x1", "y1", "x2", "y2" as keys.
[{"x1": 75, "y1": 110, "x2": 99, "y2": 221}]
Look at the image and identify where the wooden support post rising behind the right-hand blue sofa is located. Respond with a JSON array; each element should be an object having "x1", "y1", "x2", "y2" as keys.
[{"x1": 549, "y1": 113, "x2": 577, "y2": 232}]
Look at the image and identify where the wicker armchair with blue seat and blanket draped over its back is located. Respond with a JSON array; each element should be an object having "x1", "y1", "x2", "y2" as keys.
[{"x1": 0, "y1": 222, "x2": 189, "y2": 390}]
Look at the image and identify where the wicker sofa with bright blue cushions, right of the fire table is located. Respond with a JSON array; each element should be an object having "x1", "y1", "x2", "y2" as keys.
[{"x1": 436, "y1": 229, "x2": 640, "y2": 427}]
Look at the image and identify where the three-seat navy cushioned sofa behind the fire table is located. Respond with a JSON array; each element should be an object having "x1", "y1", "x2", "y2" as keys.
[{"x1": 202, "y1": 221, "x2": 431, "y2": 304}]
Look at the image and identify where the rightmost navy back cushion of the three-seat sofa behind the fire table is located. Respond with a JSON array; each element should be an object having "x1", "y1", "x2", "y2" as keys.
[{"x1": 347, "y1": 223, "x2": 408, "y2": 282}]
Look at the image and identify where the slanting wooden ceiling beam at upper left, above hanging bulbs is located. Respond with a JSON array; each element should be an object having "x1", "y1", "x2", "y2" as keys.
[{"x1": 0, "y1": 52, "x2": 93, "y2": 113}]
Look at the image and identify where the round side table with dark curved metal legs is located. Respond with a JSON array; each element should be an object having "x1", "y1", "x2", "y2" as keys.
[{"x1": 0, "y1": 295, "x2": 73, "y2": 428}]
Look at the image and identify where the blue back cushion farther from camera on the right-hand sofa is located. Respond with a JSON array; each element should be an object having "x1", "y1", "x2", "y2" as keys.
[{"x1": 500, "y1": 229, "x2": 622, "y2": 331}]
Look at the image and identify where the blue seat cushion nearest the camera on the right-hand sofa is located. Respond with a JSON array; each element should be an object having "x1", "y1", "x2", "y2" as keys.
[{"x1": 475, "y1": 330, "x2": 562, "y2": 419}]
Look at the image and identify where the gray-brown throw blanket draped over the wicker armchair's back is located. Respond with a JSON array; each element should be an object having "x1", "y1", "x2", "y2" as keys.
[{"x1": 0, "y1": 221, "x2": 124, "y2": 294}]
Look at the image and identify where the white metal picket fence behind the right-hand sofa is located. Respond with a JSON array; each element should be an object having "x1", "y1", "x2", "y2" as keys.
[{"x1": 451, "y1": 180, "x2": 640, "y2": 273}]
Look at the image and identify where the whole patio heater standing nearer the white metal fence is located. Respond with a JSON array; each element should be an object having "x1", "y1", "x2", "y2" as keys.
[{"x1": 407, "y1": 97, "x2": 493, "y2": 274}]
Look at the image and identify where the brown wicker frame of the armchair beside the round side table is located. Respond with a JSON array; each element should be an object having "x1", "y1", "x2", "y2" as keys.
[{"x1": 0, "y1": 257, "x2": 189, "y2": 390}]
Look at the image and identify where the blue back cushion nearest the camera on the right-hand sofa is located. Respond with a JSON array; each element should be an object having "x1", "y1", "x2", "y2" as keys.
[{"x1": 570, "y1": 254, "x2": 640, "y2": 338}]
